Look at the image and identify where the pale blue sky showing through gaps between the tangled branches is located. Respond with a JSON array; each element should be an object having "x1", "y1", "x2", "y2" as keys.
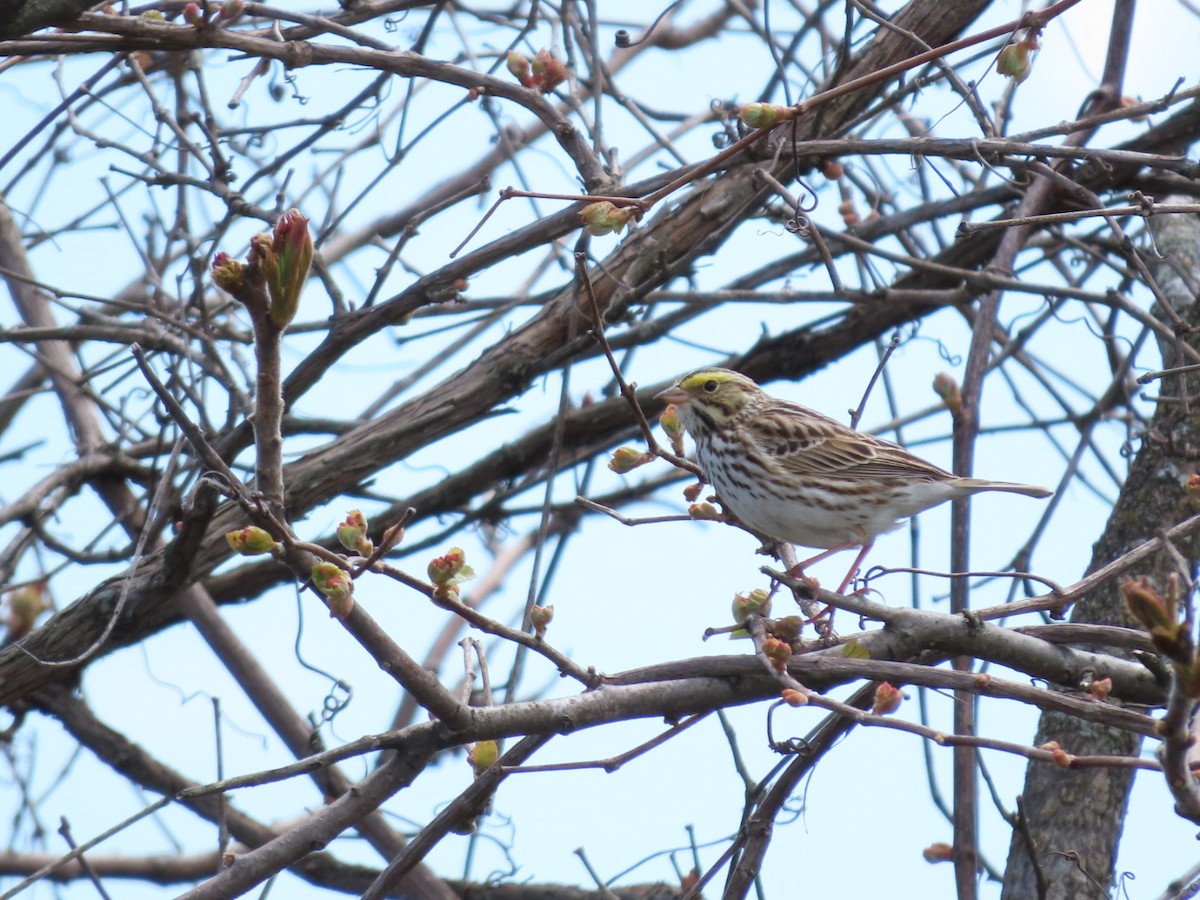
[{"x1": 0, "y1": 0, "x2": 1200, "y2": 900}]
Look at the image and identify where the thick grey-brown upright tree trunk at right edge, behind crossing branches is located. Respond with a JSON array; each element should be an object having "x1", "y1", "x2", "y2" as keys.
[{"x1": 1001, "y1": 200, "x2": 1200, "y2": 900}]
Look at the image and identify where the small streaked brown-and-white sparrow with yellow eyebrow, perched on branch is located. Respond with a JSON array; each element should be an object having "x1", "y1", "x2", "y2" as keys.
[{"x1": 659, "y1": 368, "x2": 1054, "y2": 594}]
